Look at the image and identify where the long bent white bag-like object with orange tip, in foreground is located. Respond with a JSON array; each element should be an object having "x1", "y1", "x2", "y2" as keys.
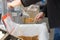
[{"x1": 2, "y1": 15, "x2": 49, "y2": 40}]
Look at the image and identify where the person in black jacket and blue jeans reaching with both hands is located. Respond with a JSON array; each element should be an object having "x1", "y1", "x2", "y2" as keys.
[{"x1": 8, "y1": 0, "x2": 60, "y2": 40}]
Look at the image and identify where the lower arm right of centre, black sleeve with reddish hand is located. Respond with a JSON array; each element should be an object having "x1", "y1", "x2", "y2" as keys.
[{"x1": 34, "y1": 5, "x2": 47, "y2": 21}]
